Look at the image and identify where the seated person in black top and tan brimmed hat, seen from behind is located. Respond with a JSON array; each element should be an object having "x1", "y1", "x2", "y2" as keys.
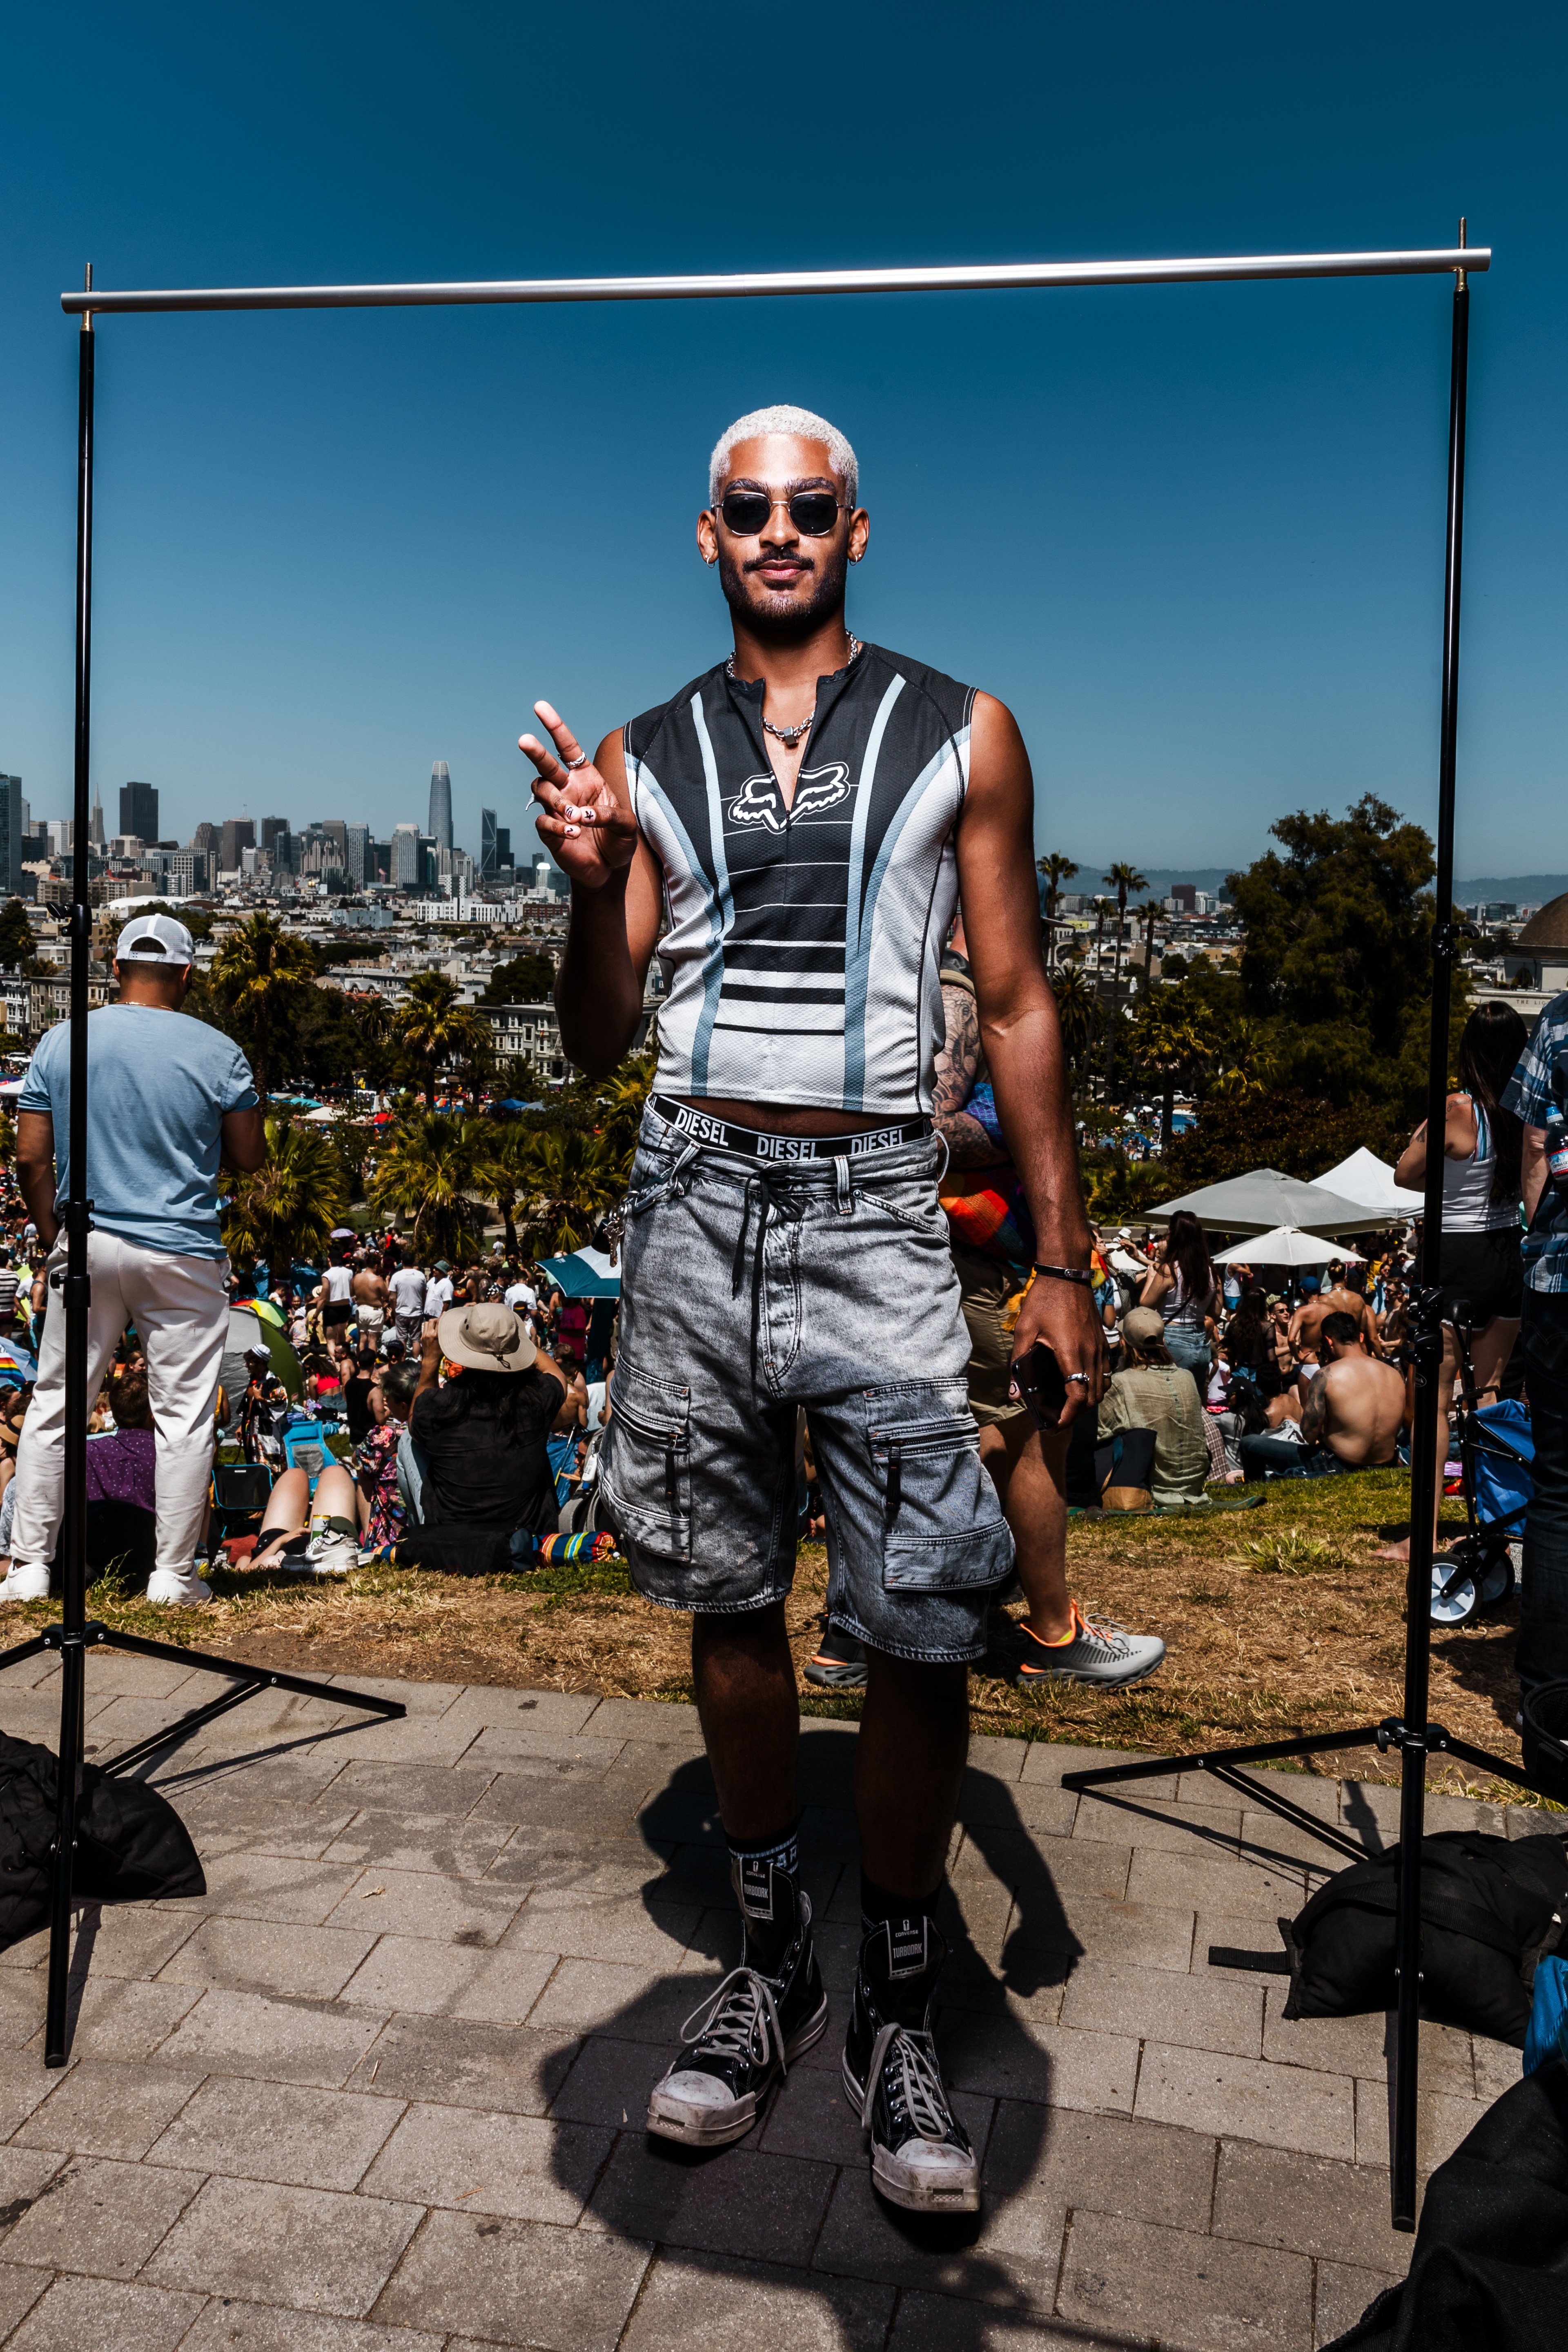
[{"x1": 409, "y1": 1298, "x2": 566, "y2": 1536}]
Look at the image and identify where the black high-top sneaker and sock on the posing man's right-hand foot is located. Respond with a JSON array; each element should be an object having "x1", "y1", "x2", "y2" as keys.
[{"x1": 844, "y1": 1917, "x2": 980, "y2": 2213}]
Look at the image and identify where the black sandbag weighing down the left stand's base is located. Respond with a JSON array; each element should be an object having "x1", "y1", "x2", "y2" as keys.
[{"x1": 0, "y1": 1731, "x2": 207, "y2": 1950}]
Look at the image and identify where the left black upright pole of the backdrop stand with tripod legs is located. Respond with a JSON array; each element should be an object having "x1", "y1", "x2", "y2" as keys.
[{"x1": 39, "y1": 270, "x2": 407, "y2": 2067}]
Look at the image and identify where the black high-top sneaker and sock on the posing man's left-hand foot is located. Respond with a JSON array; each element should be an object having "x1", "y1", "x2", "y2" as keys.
[{"x1": 649, "y1": 1863, "x2": 828, "y2": 2147}]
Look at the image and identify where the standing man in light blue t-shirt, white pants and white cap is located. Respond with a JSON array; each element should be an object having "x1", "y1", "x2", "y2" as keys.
[{"x1": 0, "y1": 915, "x2": 266, "y2": 1604}]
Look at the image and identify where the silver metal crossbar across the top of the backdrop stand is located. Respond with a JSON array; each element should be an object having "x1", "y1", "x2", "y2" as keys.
[{"x1": 59, "y1": 245, "x2": 1493, "y2": 315}]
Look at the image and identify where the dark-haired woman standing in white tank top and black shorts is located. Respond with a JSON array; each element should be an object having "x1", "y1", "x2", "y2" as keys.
[{"x1": 1378, "y1": 997, "x2": 1528, "y2": 1559}]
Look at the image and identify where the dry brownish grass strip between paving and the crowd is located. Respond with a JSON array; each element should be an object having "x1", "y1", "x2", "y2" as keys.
[{"x1": 18, "y1": 1470, "x2": 1519, "y2": 1795}]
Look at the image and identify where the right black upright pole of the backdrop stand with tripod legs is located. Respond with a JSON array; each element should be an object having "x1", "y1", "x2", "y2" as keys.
[{"x1": 1062, "y1": 243, "x2": 1533, "y2": 2230}]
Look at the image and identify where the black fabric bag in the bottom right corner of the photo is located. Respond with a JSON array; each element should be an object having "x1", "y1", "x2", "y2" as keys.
[{"x1": 1326, "y1": 2058, "x2": 1568, "y2": 2352}]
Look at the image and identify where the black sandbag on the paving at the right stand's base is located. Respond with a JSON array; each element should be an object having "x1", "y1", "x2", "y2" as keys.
[{"x1": 1279, "y1": 1830, "x2": 1568, "y2": 2049}]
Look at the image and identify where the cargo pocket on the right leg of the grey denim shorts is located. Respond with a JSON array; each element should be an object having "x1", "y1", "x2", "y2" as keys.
[{"x1": 865, "y1": 1383, "x2": 1013, "y2": 1592}]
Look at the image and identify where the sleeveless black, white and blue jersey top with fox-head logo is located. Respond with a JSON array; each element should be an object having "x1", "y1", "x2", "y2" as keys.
[{"x1": 623, "y1": 644, "x2": 976, "y2": 1120}]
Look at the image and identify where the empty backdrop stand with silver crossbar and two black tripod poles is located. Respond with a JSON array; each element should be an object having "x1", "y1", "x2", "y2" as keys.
[{"x1": 52, "y1": 221, "x2": 1533, "y2": 2192}]
